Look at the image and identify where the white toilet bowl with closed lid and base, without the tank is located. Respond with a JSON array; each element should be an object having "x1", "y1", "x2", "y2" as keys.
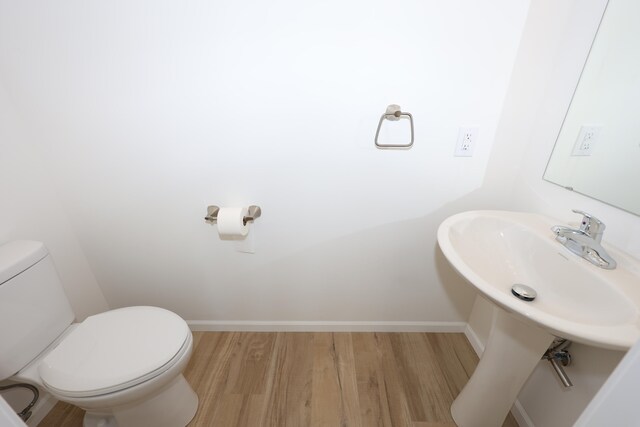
[{"x1": 19, "y1": 307, "x2": 198, "y2": 427}]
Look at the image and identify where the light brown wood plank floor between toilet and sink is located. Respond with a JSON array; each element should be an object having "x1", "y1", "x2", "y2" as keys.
[{"x1": 40, "y1": 332, "x2": 517, "y2": 427}]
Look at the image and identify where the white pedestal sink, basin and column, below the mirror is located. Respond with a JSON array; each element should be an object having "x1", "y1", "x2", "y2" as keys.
[{"x1": 438, "y1": 211, "x2": 640, "y2": 427}]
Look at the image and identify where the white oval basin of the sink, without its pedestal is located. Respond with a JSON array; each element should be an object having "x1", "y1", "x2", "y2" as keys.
[{"x1": 438, "y1": 211, "x2": 640, "y2": 350}]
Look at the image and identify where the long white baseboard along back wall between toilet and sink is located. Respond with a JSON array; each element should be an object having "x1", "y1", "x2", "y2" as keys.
[{"x1": 187, "y1": 320, "x2": 467, "y2": 332}]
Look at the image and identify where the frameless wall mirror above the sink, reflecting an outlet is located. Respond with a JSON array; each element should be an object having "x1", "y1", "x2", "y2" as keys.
[{"x1": 544, "y1": 0, "x2": 640, "y2": 215}]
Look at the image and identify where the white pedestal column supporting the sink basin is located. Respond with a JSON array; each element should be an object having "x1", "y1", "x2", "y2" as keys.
[{"x1": 451, "y1": 307, "x2": 554, "y2": 427}]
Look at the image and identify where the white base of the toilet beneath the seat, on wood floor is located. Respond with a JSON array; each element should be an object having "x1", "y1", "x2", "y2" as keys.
[{"x1": 83, "y1": 374, "x2": 198, "y2": 427}]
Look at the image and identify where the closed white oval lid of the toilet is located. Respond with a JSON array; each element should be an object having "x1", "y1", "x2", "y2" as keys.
[{"x1": 38, "y1": 307, "x2": 191, "y2": 396}]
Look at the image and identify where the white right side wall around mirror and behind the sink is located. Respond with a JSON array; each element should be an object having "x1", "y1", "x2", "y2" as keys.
[{"x1": 469, "y1": 0, "x2": 640, "y2": 427}]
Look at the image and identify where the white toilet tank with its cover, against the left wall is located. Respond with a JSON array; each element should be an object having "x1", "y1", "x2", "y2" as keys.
[{"x1": 0, "y1": 240, "x2": 75, "y2": 381}]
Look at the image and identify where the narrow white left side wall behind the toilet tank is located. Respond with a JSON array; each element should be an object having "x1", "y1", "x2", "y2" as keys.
[{"x1": 0, "y1": 84, "x2": 107, "y2": 320}]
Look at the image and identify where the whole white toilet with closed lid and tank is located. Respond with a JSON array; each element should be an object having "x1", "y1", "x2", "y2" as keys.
[{"x1": 0, "y1": 240, "x2": 198, "y2": 427}]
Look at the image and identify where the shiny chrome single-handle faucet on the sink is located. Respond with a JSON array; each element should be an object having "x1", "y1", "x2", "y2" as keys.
[{"x1": 551, "y1": 209, "x2": 616, "y2": 270}]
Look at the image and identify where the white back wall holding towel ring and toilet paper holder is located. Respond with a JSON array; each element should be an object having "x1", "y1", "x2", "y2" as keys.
[{"x1": 0, "y1": 0, "x2": 528, "y2": 324}]
